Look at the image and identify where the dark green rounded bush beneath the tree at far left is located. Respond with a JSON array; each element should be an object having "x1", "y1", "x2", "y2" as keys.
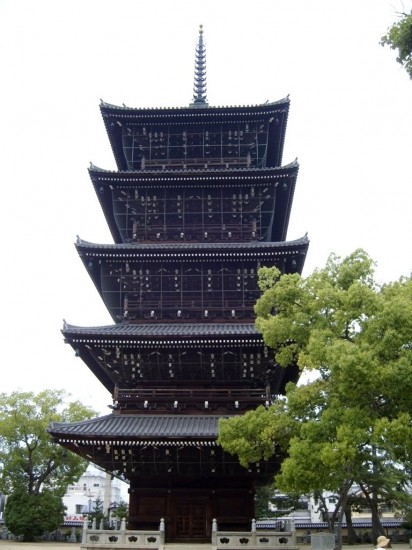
[{"x1": 4, "y1": 490, "x2": 65, "y2": 541}]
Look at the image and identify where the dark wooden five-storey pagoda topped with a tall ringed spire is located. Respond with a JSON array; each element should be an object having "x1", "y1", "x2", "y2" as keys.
[{"x1": 50, "y1": 25, "x2": 308, "y2": 540}]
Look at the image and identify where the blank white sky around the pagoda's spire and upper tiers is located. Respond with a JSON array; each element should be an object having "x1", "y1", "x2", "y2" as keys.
[{"x1": 0, "y1": 0, "x2": 412, "y2": 413}]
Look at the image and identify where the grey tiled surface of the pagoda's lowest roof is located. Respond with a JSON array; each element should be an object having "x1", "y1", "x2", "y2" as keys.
[{"x1": 48, "y1": 414, "x2": 227, "y2": 441}]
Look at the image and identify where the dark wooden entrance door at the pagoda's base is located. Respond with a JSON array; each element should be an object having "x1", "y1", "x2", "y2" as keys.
[{"x1": 175, "y1": 498, "x2": 210, "y2": 540}]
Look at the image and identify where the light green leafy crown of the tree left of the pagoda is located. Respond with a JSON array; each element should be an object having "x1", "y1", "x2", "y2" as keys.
[{"x1": 0, "y1": 390, "x2": 94, "y2": 496}]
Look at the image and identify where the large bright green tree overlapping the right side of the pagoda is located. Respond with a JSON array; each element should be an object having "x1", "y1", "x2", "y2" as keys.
[{"x1": 219, "y1": 250, "x2": 412, "y2": 548}]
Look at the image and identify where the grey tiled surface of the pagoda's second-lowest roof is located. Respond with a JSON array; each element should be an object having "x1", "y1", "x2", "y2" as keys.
[{"x1": 63, "y1": 322, "x2": 261, "y2": 340}]
